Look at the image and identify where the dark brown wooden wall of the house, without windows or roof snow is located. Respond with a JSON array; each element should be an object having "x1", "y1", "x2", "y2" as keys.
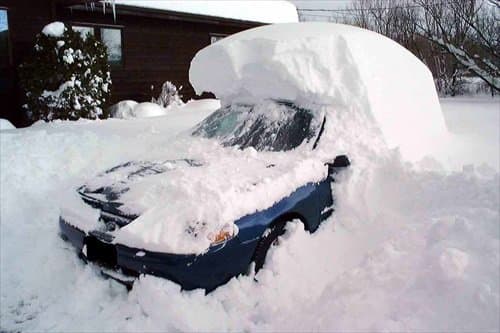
[{"x1": 0, "y1": 0, "x2": 259, "y2": 125}]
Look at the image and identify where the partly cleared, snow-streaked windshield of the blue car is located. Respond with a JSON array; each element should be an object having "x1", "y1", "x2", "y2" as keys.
[{"x1": 193, "y1": 100, "x2": 322, "y2": 151}]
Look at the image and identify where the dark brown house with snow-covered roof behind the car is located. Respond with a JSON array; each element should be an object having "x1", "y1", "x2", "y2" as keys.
[{"x1": 0, "y1": 0, "x2": 297, "y2": 126}]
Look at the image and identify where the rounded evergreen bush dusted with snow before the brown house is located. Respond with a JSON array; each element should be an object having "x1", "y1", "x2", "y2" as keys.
[{"x1": 20, "y1": 22, "x2": 111, "y2": 121}]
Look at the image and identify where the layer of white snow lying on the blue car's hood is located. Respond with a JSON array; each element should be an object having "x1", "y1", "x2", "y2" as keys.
[{"x1": 61, "y1": 131, "x2": 327, "y2": 254}]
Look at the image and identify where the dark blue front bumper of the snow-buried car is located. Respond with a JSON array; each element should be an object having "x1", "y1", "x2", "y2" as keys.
[{"x1": 59, "y1": 217, "x2": 256, "y2": 291}]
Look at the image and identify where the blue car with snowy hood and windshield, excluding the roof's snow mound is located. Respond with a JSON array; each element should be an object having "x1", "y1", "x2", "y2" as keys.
[{"x1": 59, "y1": 100, "x2": 349, "y2": 291}]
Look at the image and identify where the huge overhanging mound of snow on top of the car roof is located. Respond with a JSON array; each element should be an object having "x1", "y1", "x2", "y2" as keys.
[{"x1": 189, "y1": 23, "x2": 446, "y2": 160}]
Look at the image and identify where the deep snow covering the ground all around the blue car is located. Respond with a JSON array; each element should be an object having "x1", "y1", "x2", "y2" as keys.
[{"x1": 0, "y1": 94, "x2": 500, "y2": 332}]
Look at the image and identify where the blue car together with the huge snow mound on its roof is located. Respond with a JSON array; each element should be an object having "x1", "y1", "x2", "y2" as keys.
[{"x1": 60, "y1": 18, "x2": 445, "y2": 290}]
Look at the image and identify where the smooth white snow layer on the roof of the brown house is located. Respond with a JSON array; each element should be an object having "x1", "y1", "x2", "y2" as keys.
[{"x1": 111, "y1": 0, "x2": 299, "y2": 23}]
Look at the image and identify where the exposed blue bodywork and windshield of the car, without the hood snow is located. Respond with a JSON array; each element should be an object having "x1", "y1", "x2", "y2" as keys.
[{"x1": 59, "y1": 100, "x2": 350, "y2": 291}]
